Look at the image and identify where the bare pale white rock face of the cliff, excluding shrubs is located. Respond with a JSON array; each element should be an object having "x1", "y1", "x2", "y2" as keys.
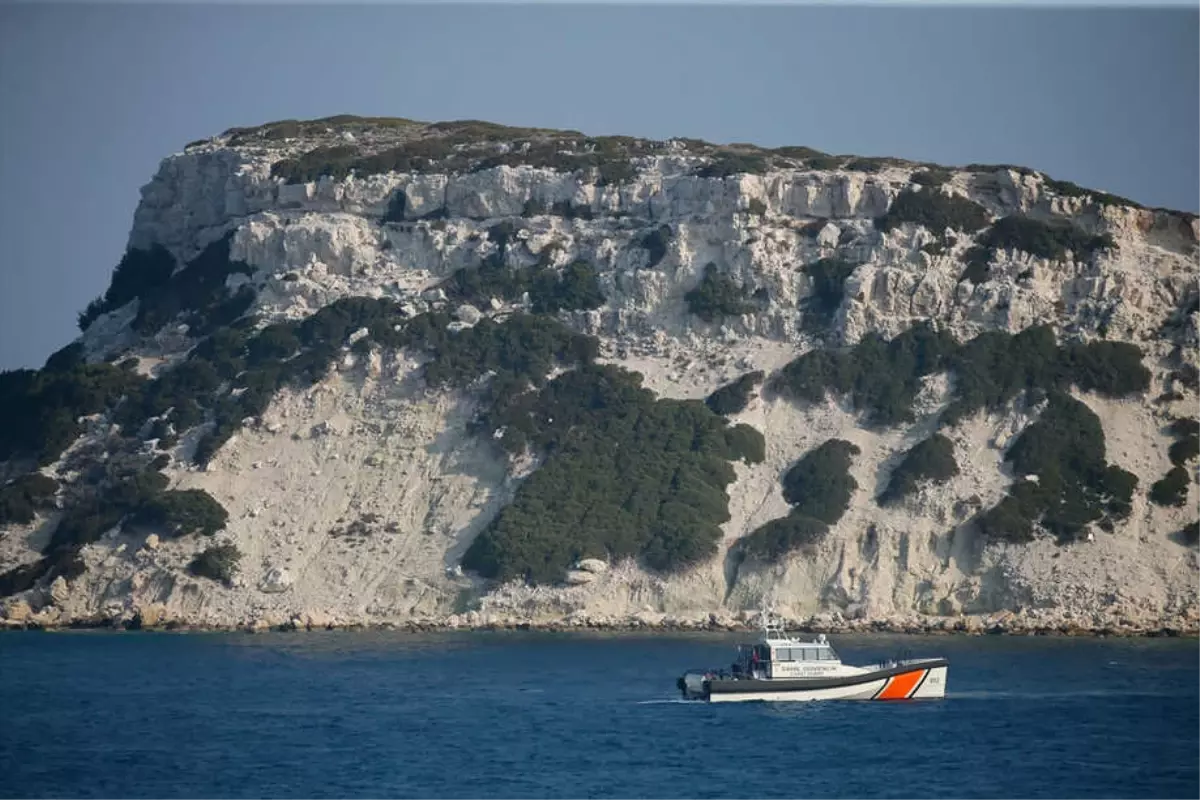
[{"x1": 7, "y1": 117, "x2": 1200, "y2": 630}]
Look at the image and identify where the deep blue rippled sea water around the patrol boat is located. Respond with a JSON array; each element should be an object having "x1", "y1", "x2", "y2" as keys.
[{"x1": 0, "y1": 632, "x2": 1200, "y2": 800}]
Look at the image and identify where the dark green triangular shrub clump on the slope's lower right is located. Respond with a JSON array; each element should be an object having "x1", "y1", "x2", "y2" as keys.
[{"x1": 978, "y1": 392, "x2": 1138, "y2": 542}]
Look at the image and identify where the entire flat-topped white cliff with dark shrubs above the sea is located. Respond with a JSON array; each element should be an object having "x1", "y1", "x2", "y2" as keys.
[{"x1": 0, "y1": 118, "x2": 1200, "y2": 631}]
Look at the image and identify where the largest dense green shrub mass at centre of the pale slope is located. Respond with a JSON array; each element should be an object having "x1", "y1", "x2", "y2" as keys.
[{"x1": 463, "y1": 366, "x2": 764, "y2": 583}]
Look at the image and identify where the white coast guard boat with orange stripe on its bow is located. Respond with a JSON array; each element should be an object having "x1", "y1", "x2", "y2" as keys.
[{"x1": 677, "y1": 619, "x2": 949, "y2": 703}]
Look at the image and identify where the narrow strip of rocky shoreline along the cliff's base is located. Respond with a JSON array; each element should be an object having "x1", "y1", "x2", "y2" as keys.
[{"x1": 0, "y1": 607, "x2": 1200, "y2": 638}]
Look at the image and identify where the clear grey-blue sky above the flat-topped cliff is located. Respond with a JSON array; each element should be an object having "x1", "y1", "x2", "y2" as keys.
[{"x1": 0, "y1": 0, "x2": 1200, "y2": 369}]
